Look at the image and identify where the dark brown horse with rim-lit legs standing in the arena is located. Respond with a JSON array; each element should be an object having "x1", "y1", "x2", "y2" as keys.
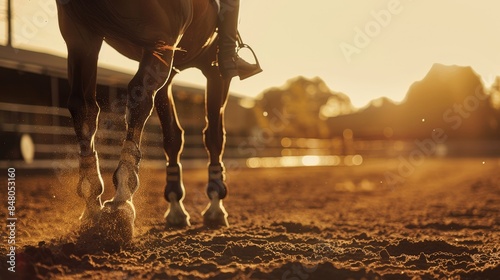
[{"x1": 57, "y1": 0, "x2": 243, "y2": 242}]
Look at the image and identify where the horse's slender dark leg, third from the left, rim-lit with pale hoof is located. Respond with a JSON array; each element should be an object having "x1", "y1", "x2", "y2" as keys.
[{"x1": 155, "y1": 77, "x2": 190, "y2": 227}]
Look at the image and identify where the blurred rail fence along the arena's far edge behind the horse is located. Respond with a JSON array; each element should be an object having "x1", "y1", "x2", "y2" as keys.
[{"x1": 0, "y1": 102, "x2": 492, "y2": 169}]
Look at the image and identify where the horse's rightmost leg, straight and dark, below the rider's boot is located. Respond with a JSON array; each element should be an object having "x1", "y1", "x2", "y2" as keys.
[{"x1": 202, "y1": 71, "x2": 231, "y2": 227}]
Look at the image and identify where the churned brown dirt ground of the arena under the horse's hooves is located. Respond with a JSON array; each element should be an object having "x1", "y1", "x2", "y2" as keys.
[{"x1": 0, "y1": 158, "x2": 500, "y2": 280}]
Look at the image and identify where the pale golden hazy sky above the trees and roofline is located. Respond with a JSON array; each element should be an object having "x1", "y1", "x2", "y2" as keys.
[{"x1": 0, "y1": 0, "x2": 500, "y2": 106}]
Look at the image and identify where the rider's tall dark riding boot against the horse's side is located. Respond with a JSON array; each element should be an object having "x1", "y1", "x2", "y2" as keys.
[{"x1": 217, "y1": 0, "x2": 262, "y2": 80}]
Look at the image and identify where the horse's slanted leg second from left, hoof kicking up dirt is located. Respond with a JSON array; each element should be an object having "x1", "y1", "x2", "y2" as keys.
[{"x1": 101, "y1": 51, "x2": 173, "y2": 242}]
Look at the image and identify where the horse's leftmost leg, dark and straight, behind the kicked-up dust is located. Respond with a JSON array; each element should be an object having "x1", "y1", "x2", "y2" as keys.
[{"x1": 61, "y1": 22, "x2": 104, "y2": 229}]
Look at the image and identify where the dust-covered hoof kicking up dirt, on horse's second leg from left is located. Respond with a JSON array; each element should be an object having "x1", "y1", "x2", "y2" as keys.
[{"x1": 99, "y1": 200, "x2": 135, "y2": 244}]
